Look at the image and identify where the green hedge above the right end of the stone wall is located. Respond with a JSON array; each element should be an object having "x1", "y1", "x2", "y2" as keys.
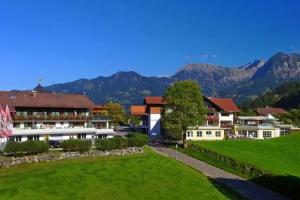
[{"x1": 95, "y1": 134, "x2": 148, "y2": 151}]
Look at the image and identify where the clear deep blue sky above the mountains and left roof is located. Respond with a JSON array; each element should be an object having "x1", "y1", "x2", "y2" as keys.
[{"x1": 0, "y1": 0, "x2": 300, "y2": 90}]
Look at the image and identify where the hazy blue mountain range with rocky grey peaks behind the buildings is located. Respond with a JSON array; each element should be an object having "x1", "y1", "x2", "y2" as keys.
[{"x1": 43, "y1": 52, "x2": 300, "y2": 108}]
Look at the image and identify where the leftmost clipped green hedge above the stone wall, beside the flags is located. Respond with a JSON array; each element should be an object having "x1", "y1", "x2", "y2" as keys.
[{"x1": 4, "y1": 140, "x2": 49, "y2": 155}]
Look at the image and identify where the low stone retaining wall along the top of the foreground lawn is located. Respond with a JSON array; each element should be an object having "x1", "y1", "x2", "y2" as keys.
[{"x1": 0, "y1": 147, "x2": 144, "y2": 168}]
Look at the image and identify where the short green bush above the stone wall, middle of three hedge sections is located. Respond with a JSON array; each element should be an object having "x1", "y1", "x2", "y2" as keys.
[{"x1": 60, "y1": 139, "x2": 91, "y2": 153}]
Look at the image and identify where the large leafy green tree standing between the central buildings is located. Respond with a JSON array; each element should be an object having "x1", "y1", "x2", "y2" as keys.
[{"x1": 162, "y1": 80, "x2": 206, "y2": 142}]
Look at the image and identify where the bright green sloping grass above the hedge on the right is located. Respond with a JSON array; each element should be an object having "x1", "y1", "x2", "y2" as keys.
[{"x1": 191, "y1": 134, "x2": 300, "y2": 177}]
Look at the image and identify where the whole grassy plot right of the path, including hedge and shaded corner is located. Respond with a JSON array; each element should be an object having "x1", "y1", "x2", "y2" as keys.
[{"x1": 181, "y1": 133, "x2": 300, "y2": 199}]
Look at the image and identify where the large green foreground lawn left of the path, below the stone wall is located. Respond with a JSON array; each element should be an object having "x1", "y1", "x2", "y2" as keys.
[{"x1": 0, "y1": 149, "x2": 227, "y2": 200}]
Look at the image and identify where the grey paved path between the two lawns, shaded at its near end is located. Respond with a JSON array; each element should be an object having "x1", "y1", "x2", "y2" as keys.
[{"x1": 152, "y1": 146, "x2": 287, "y2": 200}]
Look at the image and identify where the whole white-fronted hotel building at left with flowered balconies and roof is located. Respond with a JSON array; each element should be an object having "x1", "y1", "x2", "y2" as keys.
[{"x1": 0, "y1": 91, "x2": 114, "y2": 146}]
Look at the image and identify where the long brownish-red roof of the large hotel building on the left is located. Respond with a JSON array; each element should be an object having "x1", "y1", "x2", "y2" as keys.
[{"x1": 0, "y1": 91, "x2": 95, "y2": 111}]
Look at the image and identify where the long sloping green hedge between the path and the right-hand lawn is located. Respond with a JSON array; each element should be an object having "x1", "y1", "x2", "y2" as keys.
[{"x1": 187, "y1": 142, "x2": 271, "y2": 178}]
